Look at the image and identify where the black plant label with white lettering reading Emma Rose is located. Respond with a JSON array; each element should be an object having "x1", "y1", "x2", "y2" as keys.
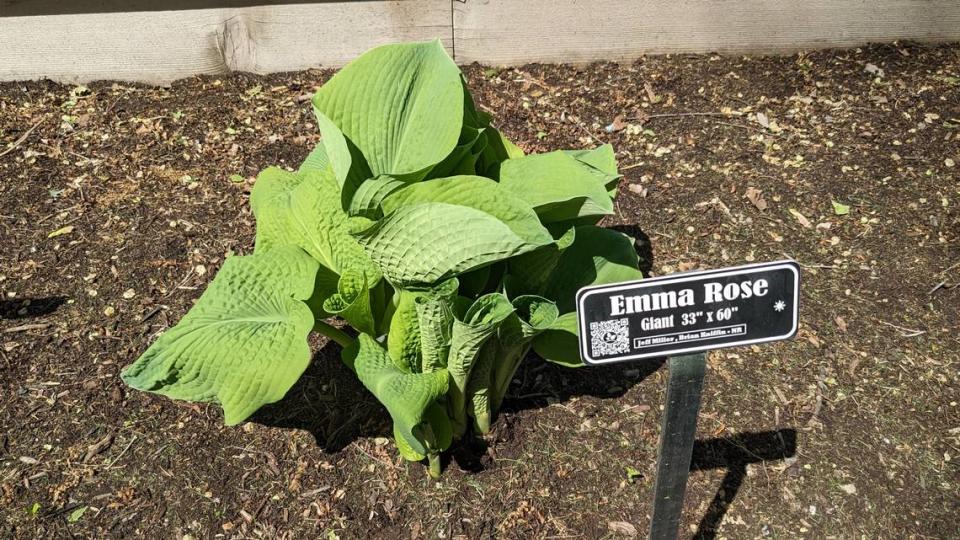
[{"x1": 577, "y1": 261, "x2": 800, "y2": 364}]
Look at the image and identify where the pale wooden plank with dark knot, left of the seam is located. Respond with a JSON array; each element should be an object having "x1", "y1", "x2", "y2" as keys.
[{"x1": 0, "y1": 0, "x2": 452, "y2": 84}]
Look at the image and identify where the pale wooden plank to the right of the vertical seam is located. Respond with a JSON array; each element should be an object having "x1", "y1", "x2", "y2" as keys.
[{"x1": 453, "y1": 0, "x2": 960, "y2": 65}]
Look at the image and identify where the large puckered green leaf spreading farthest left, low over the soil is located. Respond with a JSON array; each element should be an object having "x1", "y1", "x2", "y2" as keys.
[{"x1": 121, "y1": 246, "x2": 318, "y2": 425}]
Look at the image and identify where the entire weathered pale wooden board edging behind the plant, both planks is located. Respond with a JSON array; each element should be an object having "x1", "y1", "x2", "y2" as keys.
[{"x1": 0, "y1": 0, "x2": 960, "y2": 83}]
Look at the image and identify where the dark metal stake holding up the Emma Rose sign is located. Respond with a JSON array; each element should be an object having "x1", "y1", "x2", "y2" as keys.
[{"x1": 650, "y1": 352, "x2": 707, "y2": 540}]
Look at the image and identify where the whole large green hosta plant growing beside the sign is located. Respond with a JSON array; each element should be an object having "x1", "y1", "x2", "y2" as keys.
[{"x1": 122, "y1": 41, "x2": 640, "y2": 475}]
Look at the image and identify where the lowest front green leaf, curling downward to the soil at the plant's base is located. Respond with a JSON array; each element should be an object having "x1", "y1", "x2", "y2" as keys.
[{"x1": 344, "y1": 334, "x2": 448, "y2": 455}]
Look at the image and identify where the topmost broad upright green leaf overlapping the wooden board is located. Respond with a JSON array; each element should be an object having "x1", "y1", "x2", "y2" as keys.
[{"x1": 313, "y1": 40, "x2": 463, "y2": 184}]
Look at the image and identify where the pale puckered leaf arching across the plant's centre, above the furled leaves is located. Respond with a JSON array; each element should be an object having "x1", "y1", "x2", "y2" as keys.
[{"x1": 355, "y1": 201, "x2": 553, "y2": 288}]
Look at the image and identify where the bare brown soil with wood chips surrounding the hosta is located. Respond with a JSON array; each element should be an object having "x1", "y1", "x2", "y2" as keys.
[{"x1": 0, "y1": 44, "x2": 960, "y2": 539}]
